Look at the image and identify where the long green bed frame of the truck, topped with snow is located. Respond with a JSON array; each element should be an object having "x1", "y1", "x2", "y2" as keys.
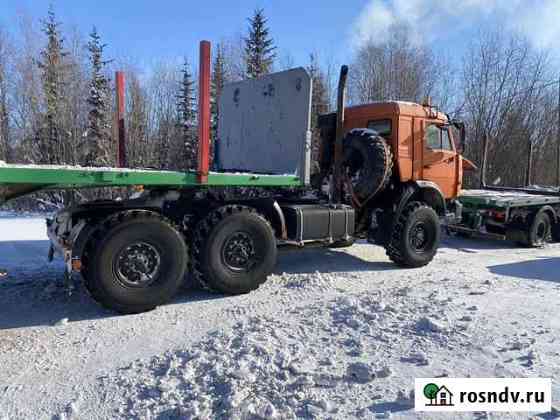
[{"x1": 0, "y1": 164, "x2": 304, "y2": 204}]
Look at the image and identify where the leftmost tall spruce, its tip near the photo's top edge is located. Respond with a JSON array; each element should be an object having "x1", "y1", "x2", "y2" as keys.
[{"x1": 36, "y1": 7, "x2": 66, "y2": 163}]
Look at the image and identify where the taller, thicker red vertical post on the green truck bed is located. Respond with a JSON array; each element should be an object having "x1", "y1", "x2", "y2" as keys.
[{"x1": 198, "y1": 41, "x2": 210, "y2": 183}]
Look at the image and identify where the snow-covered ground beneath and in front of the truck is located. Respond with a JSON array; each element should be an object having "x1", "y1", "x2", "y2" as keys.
[{"x1": 0, "y1": 215, "x2": 560, "y2": 419}]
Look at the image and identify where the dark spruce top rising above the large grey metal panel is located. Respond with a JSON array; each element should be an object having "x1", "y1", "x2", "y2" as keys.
[{"x1": 245, "y1": 9, "x2": 276, "y2": 79}]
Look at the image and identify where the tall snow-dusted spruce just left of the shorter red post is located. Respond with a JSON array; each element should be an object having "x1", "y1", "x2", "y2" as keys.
[{"x1": 83, "y1": 26, "x2": 112, "y2": 166}]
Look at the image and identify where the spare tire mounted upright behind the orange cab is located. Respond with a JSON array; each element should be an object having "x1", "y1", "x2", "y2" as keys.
[{"x1": 342, "y1": 129, "x2": 393, "y2": 199}]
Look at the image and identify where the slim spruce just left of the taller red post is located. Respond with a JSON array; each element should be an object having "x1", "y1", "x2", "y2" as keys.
[{"x1": 177, "y1": 60, "x2": 198, "y2": 170}]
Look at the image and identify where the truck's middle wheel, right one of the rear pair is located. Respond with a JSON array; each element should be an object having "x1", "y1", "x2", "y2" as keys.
[{"x1": 192, "y1": 205, "x2": 277, "y2": 294}]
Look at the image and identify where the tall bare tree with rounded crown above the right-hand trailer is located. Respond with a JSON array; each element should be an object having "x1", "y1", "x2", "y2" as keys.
[{"x1": 462, "y1": 31, "x2": 551, "y2": 186}]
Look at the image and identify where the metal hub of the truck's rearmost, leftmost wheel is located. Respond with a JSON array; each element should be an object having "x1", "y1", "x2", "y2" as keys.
[{"x1": 116, "y1": 242, "x2": 161, "y2": 287}]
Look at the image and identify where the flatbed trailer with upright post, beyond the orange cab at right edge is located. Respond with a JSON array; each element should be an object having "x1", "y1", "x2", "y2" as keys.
[{"x1": 447, "y1": 136, "x2": 560, "y2": 247}]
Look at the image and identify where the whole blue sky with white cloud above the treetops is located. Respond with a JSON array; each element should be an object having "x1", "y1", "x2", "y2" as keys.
[{"x1": 0, "y1": 0, "x2": 560, "y2": 71}]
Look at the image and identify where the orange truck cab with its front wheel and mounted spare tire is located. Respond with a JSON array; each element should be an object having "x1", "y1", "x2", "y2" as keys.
[{"x1": 314, "y1": 71, "x2": 475, "y2": 267}]
